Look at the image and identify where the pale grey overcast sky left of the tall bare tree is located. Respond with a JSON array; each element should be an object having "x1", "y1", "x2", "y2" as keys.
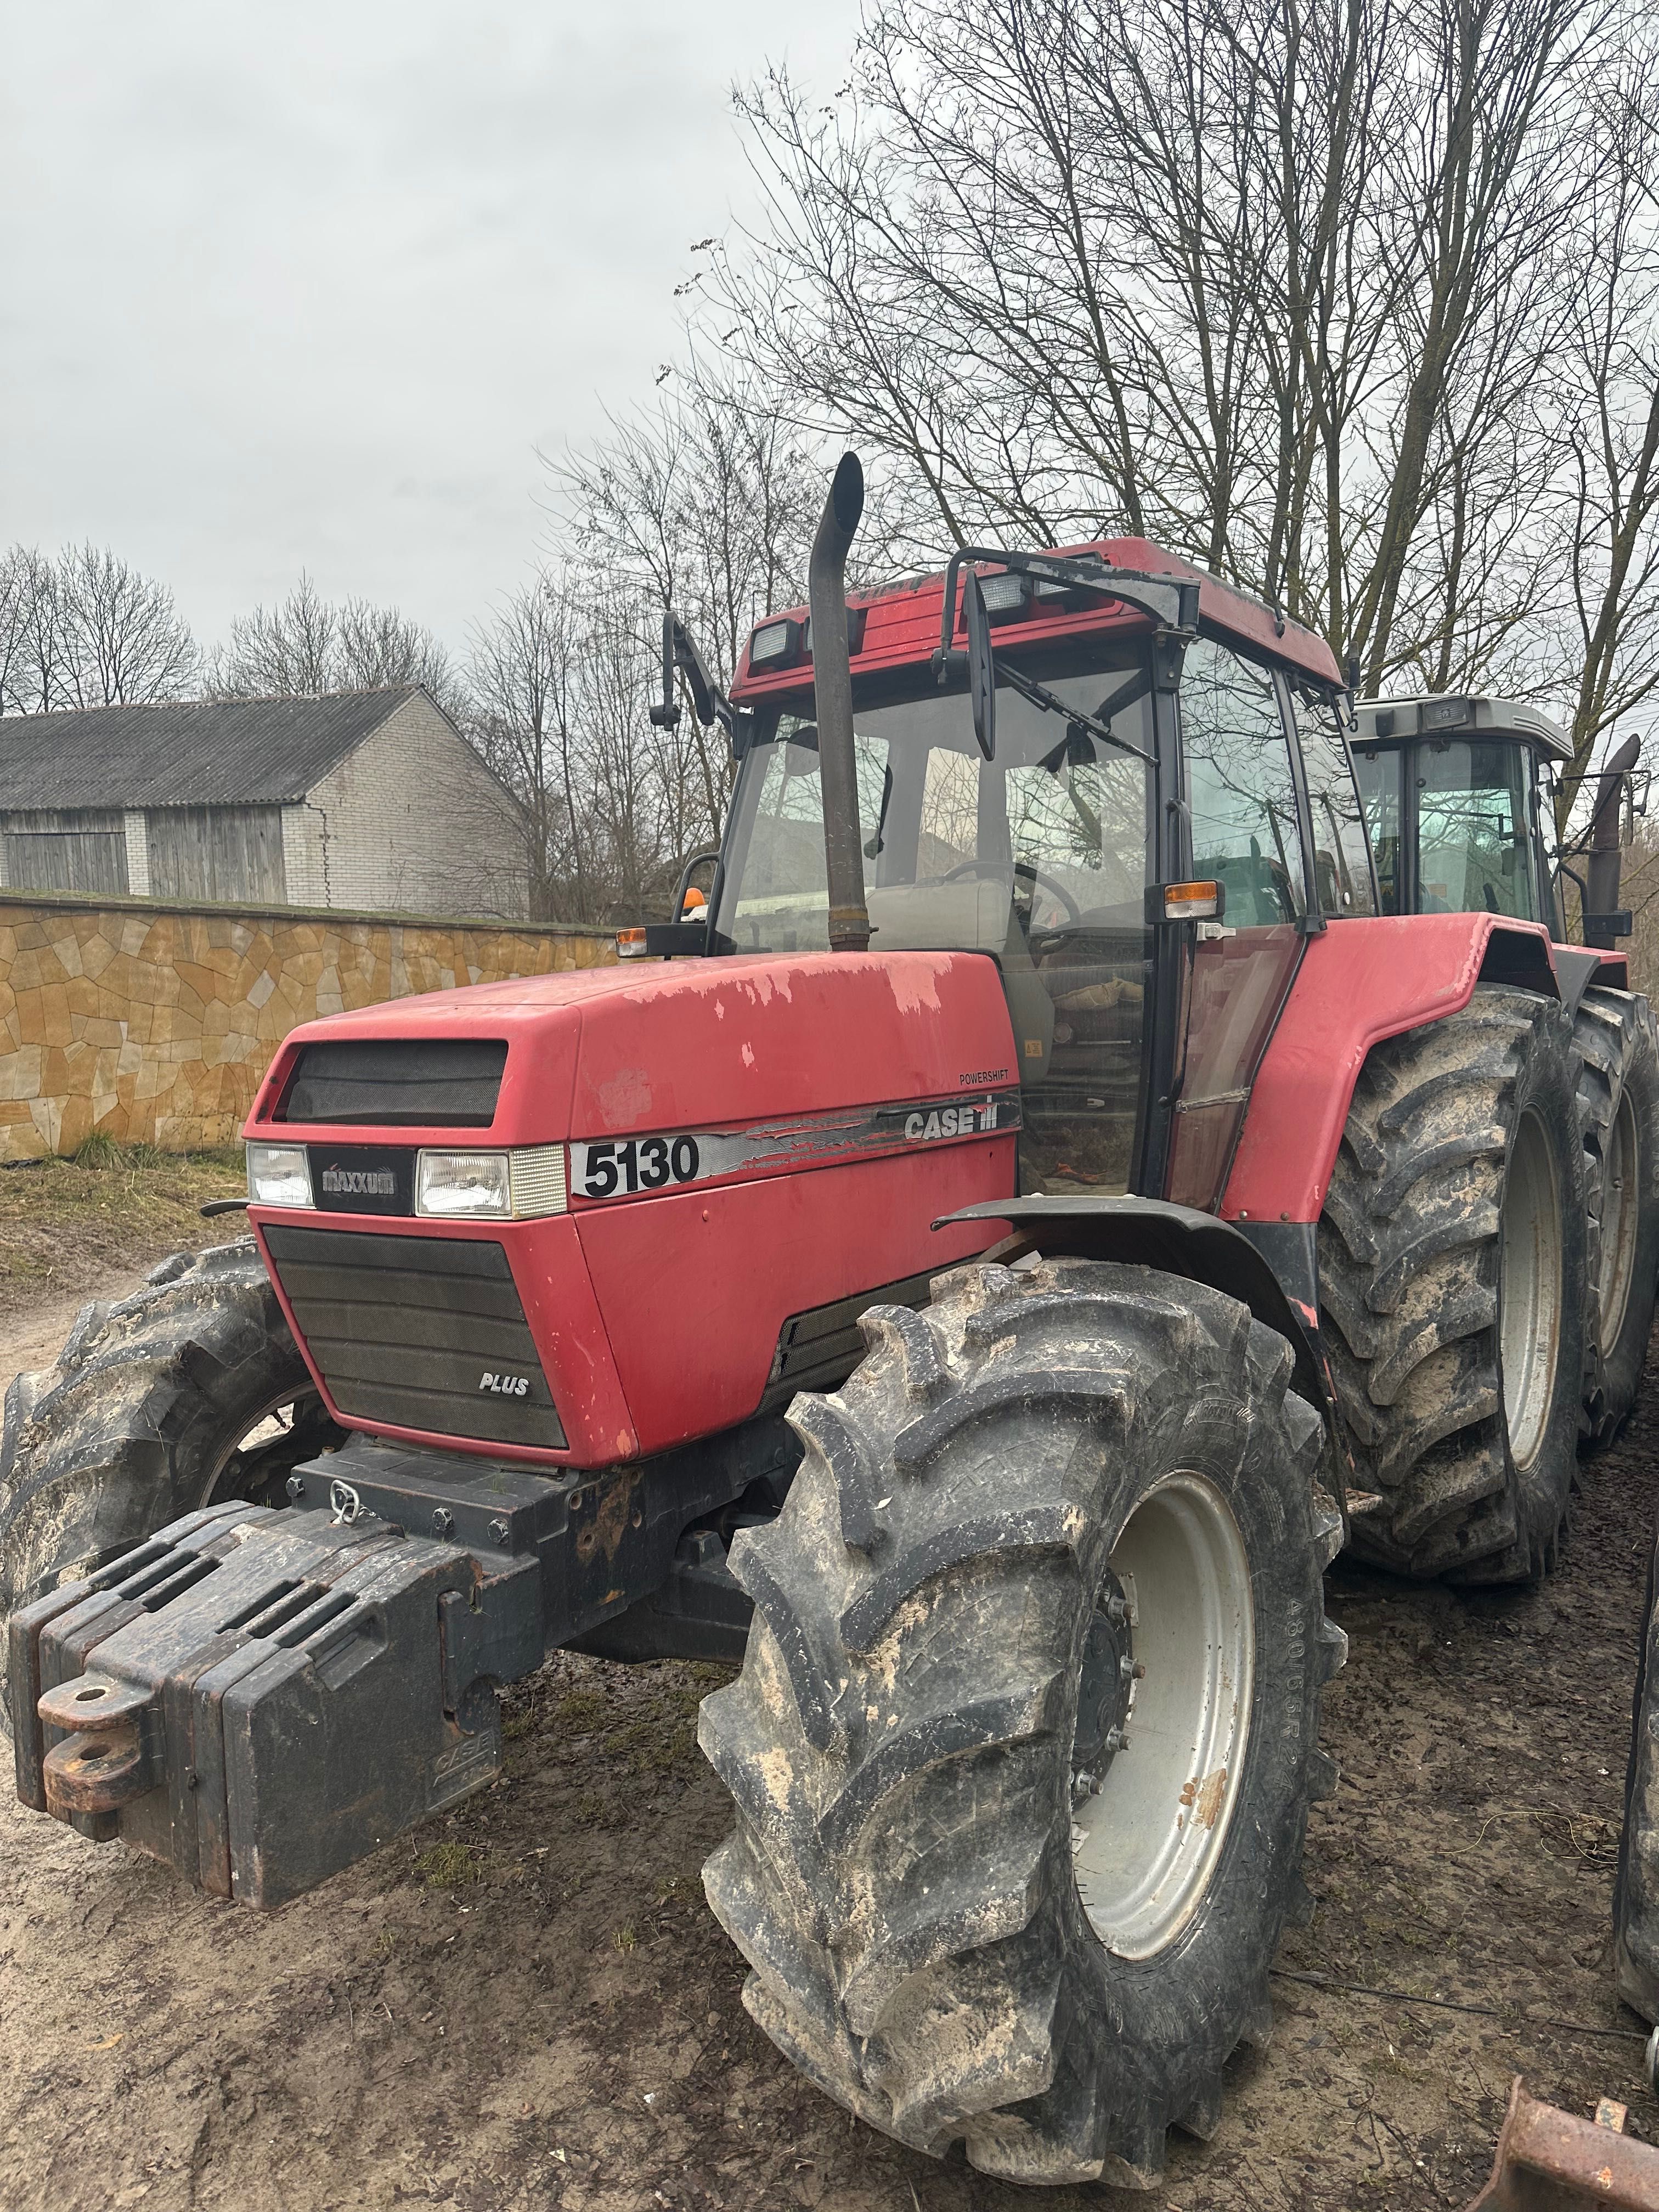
[{"x1": 0, "y1": 0, "x2": 858, "y2": 644}]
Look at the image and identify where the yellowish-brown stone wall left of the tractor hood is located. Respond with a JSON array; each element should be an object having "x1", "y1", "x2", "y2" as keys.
[{"x1": 0, "y1": 894, "x2": 615, "y2": 1161}]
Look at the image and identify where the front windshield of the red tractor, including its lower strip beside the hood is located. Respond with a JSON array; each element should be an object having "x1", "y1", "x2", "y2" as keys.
[{"x1": 714, "y1": 652, "x2": 1153, "y2": 1192}]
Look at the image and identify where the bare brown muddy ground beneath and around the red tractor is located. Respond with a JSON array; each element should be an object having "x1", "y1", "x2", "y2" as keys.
[{"x1": 0, "y1": 1186, "x2": 1659, "y2": 2212}]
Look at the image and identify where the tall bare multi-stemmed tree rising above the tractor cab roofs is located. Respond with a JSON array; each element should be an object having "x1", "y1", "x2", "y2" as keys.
[{"x1": 708, "y1": 0, "x2": 1652, "y2": 688}]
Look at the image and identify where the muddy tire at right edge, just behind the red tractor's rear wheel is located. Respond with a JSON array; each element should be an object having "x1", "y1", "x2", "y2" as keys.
[{"x1": 1573, "y1": 989, "x2": 1659, "y2": 1447}]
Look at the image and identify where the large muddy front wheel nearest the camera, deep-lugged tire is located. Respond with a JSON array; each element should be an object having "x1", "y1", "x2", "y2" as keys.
[{"x1": 699, "y1": 1261, "x2": 1345, "y2": 2186}]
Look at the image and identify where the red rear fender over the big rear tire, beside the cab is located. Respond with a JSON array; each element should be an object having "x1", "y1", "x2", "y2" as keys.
[{"x1": 1221, "y1": 913, "x2": 1575, "y2": 1230}]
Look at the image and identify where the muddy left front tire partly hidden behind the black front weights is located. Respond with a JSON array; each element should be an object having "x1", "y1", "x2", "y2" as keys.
[{"x1": 0, "y1": 1239, "x2": 338, "y2": 1619}]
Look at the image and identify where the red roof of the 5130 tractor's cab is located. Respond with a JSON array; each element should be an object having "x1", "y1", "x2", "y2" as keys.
[{"x1": 732, "y1": 538, "x2": 1342, "y2": 706}]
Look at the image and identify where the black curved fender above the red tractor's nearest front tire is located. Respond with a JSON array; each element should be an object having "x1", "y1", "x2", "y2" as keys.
[{"x1": 934, "y1": 1192, "x2": 1347, "y2": 1531}]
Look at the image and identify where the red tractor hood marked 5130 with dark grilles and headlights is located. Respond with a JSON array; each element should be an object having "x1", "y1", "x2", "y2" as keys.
[{"x1": 246, "y1": 951, "x2": 1020, "y2": 1466}]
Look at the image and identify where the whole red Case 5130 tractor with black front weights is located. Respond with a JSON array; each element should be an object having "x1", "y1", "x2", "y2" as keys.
[{"x1": 0, "y1": 456, "x2": 1654, "y2": 2186}]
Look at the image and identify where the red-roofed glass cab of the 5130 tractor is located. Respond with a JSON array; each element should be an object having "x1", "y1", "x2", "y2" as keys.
[{"x1": 676, "y1": 540, "x2": 1374, "y2": 1207}]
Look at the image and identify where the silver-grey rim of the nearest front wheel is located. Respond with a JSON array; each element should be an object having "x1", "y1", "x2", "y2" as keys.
[{"x1": 1073, "y1": 1471, "x2": 1256, "y2": 1957}]
